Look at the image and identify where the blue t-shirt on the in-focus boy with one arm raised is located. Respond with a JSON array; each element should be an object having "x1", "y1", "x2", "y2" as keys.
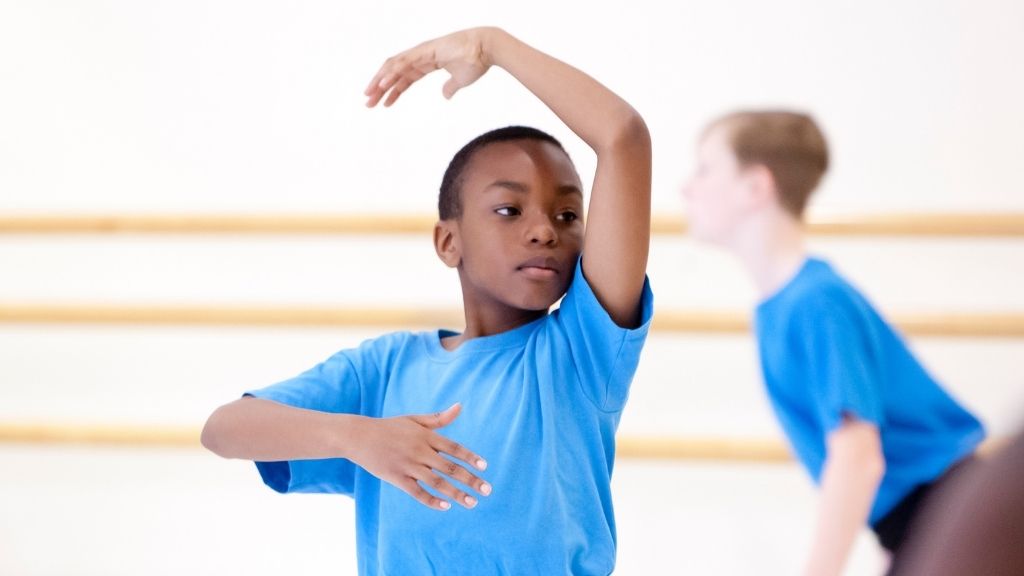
[{"x1": 243, "y1": 261, "x2": 652, "y2": 576}]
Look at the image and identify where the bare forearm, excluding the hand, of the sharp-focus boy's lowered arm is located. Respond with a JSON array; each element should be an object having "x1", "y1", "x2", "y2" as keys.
[{"x1": 201, "y1": 398, "x2": 361, "y2": 462}]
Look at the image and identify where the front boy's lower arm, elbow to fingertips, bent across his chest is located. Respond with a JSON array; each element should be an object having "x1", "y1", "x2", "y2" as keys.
[{"x1": 201, "y1": 398, "x2": 490, "y2": 509}]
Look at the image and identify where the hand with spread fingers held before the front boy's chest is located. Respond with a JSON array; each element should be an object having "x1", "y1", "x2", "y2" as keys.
[{"x1": 350, "y1": 404, "x2": 490, "y2": 510}]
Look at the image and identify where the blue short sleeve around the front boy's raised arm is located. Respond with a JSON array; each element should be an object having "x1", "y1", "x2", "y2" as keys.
[{"x1": 557, "y1": 258, "x2": 654, "y2": 412}]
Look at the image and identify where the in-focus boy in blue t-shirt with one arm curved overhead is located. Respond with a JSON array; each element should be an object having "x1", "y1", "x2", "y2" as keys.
[{"x1": 203, "y1": 28, "x2": 652, "y2": 575}]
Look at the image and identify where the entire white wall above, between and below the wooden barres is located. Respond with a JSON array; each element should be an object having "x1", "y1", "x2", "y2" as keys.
[{"x1": 0, "y1": 0, "x2": 1024, "y2": 575}]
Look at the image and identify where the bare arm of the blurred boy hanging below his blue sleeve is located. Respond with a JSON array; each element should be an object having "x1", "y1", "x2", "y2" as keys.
[{"x1": 804, "y1": 418, "x2": 886, "y2": 576}]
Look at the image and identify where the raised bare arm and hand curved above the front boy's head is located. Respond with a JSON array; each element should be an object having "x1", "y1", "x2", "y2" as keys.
[{"x1": 367, "y1": 28, "x2": 651, "y2": 327}]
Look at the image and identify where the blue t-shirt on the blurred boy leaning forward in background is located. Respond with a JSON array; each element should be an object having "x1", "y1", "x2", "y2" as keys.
[{"x1": 756, "y1": 258, "x2": 985, "y2": 525}]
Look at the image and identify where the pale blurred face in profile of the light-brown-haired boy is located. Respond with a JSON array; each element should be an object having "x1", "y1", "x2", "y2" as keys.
[{"x1": 682, "y1": 126, "x2": 751, "y2": 245}]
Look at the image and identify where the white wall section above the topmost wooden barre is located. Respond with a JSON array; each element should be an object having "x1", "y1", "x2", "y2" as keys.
[{"x1": 6, "y1": 0, "x2": 1024, "y2": 211}]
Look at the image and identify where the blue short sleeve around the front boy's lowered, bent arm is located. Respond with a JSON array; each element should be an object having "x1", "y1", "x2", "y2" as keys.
[{"x1": 246, "y1": 351, "x2": 360, "y2": 495}]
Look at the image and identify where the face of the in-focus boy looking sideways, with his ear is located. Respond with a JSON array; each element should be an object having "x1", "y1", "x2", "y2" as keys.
[{"x1": 437, "y1": 139, "x2": 584, "y2": 311}]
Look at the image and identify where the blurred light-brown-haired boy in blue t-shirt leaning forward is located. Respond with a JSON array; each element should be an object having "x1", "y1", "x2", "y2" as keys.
[{"x1": 683, "y1": 112, "x2": 984, "y2": 576}]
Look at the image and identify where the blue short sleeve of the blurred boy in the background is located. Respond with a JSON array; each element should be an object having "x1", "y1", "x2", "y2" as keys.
[{"x1": 797, "y1": 294, "x2": 884, "y2": 430}]
